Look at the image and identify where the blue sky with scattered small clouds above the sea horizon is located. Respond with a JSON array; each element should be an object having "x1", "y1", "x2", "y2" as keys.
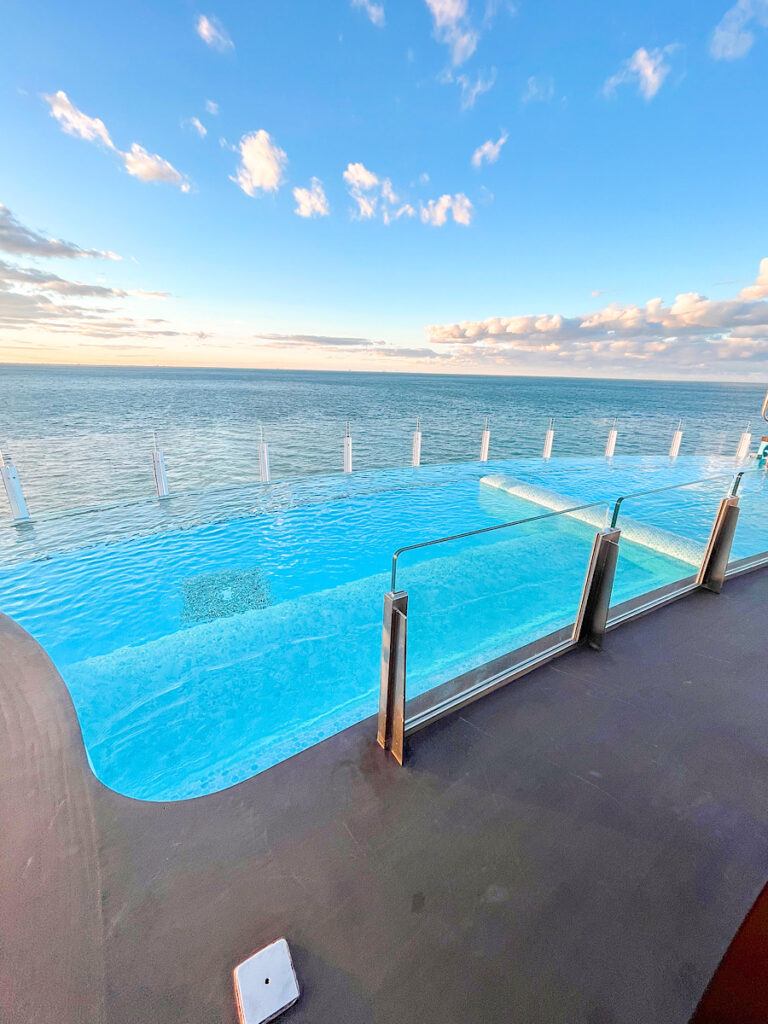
[{"x1": 0, "y1": 0, "x2": 768, "y2": 381}]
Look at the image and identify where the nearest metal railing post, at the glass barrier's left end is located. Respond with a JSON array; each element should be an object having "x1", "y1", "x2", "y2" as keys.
[{"x1": 377, "y1": 590, "x2": 408, "y2": 765}]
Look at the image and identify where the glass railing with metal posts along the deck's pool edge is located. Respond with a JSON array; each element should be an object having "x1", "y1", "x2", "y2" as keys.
[{"x1": 379, "y1": 467, "x2": 768, "y2": 760}]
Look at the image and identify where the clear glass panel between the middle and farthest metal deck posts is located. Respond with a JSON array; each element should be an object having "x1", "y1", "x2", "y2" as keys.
[{"x1": 611, "y1": 476, "x2": 729, "y2": 608}]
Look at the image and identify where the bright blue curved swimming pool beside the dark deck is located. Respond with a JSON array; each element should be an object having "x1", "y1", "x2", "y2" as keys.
[{"x1": 0, "y1": 457, "x2": 768, "y2": 800}]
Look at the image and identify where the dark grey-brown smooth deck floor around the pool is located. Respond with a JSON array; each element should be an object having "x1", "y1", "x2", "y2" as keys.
[{"x1": 0, "y1": 569, "x2": 768, "y2": 1024}]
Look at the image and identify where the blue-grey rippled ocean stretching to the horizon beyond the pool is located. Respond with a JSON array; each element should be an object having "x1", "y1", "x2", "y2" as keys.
[{"x1": 0, "y1": 366, "x2": 764, "y2": 518}]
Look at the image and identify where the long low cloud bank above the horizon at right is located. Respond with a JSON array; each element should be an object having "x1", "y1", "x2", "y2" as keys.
[{"x1": 426, "y1": 257, "x2": 768, "y2": 371}]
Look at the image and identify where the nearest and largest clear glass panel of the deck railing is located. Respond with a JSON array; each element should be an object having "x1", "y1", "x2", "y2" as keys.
[{"x1": 396, "y1": 496, "x2": 607, "y2": 698}]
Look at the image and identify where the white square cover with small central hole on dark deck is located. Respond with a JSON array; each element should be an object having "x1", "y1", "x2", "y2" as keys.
[{"x1": 234, "y1": 939, "x2": 299, "y2": 1024}]
